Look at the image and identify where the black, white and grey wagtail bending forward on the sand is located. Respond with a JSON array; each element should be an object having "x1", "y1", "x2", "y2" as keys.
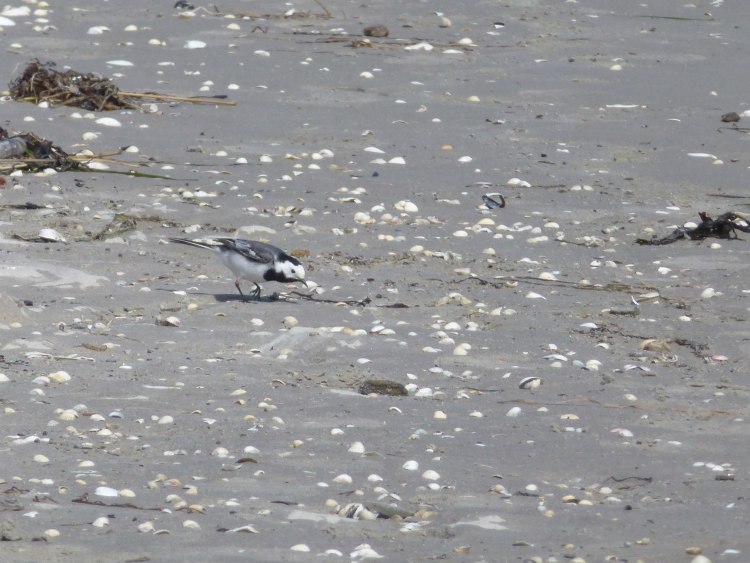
[{"x1": 169, "y1": 238, "x2": 307, "y2": 298}]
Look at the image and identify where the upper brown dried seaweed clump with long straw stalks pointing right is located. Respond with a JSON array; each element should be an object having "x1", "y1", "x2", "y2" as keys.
[{"x1": 8, "y1": 59, "x2": 236, "y2": 111}]
